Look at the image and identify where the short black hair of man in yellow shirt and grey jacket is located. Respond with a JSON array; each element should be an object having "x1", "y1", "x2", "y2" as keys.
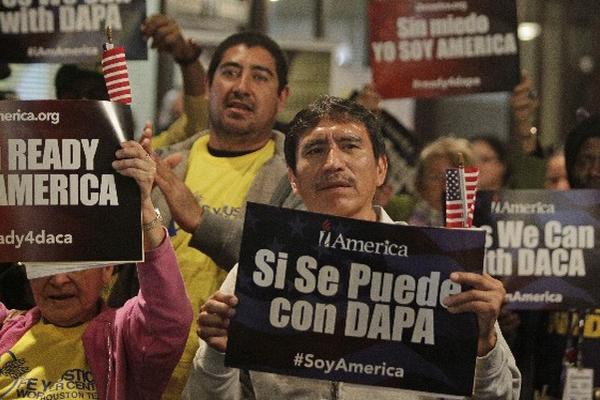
[{"x1": 207, "y1": 31, "x2": 288, "y2": 93}]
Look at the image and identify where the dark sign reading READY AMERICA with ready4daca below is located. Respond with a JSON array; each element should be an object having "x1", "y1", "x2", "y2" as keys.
[{"x1": 0, "y1": 100, "x2": 143, "y2": 262}]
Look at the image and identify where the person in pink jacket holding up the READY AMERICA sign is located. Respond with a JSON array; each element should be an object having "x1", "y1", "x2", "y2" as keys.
[{"x1": 0, "y1": 141, "x2": 192, "y2": 400}]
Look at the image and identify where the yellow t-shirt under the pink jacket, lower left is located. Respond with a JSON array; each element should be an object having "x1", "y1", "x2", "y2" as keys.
[{"x1": 0, "y1": 321, "x2": 98, "y2": 399}]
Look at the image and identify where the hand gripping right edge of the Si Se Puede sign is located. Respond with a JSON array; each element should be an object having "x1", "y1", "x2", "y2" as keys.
[{"x1": 443, "y1": 272, "x2": 506, "y2": 357}]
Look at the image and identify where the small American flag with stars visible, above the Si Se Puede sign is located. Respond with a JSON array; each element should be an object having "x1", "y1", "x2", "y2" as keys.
[{"x1": 446, "y1": 167, "x2": 479, "y2": 228}]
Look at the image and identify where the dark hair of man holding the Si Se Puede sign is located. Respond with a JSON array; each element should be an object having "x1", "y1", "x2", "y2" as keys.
[{"x1": 285, "y1": 96, "x2": 386, "y2": 173}]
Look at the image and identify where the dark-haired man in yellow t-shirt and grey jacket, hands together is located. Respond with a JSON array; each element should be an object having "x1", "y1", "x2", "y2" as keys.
[{"x1": 110, "y1": 32, "x2": 301, "y2": 399}]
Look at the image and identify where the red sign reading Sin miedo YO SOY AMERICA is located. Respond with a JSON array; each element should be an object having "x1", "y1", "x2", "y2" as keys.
[{"x1": 369, "y1": 0, "x2": 519, "y2": 98}]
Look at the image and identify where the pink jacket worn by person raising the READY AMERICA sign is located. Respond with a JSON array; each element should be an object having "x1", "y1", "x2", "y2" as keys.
[{"x1": 0, "y1": 234, "x2": 193, "y2": 400}]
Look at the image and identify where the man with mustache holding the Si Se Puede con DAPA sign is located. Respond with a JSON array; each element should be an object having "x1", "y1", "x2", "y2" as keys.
[{"x1": 184, "y1": 96, "x2": 520, "y2": 400}]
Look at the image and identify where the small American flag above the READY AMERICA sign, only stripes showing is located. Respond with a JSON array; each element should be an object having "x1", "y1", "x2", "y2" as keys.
[{"x1": 102, "y1": 45, "x2": 131, "y2": 104}]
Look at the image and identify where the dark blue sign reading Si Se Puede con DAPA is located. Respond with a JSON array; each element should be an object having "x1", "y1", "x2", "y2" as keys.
[{"x1": 225, "y1": 203, "x2": 484, "y2": 396}]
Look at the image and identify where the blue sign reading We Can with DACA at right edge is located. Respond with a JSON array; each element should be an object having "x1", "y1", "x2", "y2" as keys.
[{"x1": 474, "y1": 190, "x2": 600, "y2": 310}]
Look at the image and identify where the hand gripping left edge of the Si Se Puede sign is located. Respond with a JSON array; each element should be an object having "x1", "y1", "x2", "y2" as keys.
[{"x1": 197, "y1": 292, "x2": 238, "y2": 353}]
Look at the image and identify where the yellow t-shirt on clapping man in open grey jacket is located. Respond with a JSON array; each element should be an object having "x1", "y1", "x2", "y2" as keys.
[{"x1": 163, "y1": 135, "x2": 275, "y2": 399}]
